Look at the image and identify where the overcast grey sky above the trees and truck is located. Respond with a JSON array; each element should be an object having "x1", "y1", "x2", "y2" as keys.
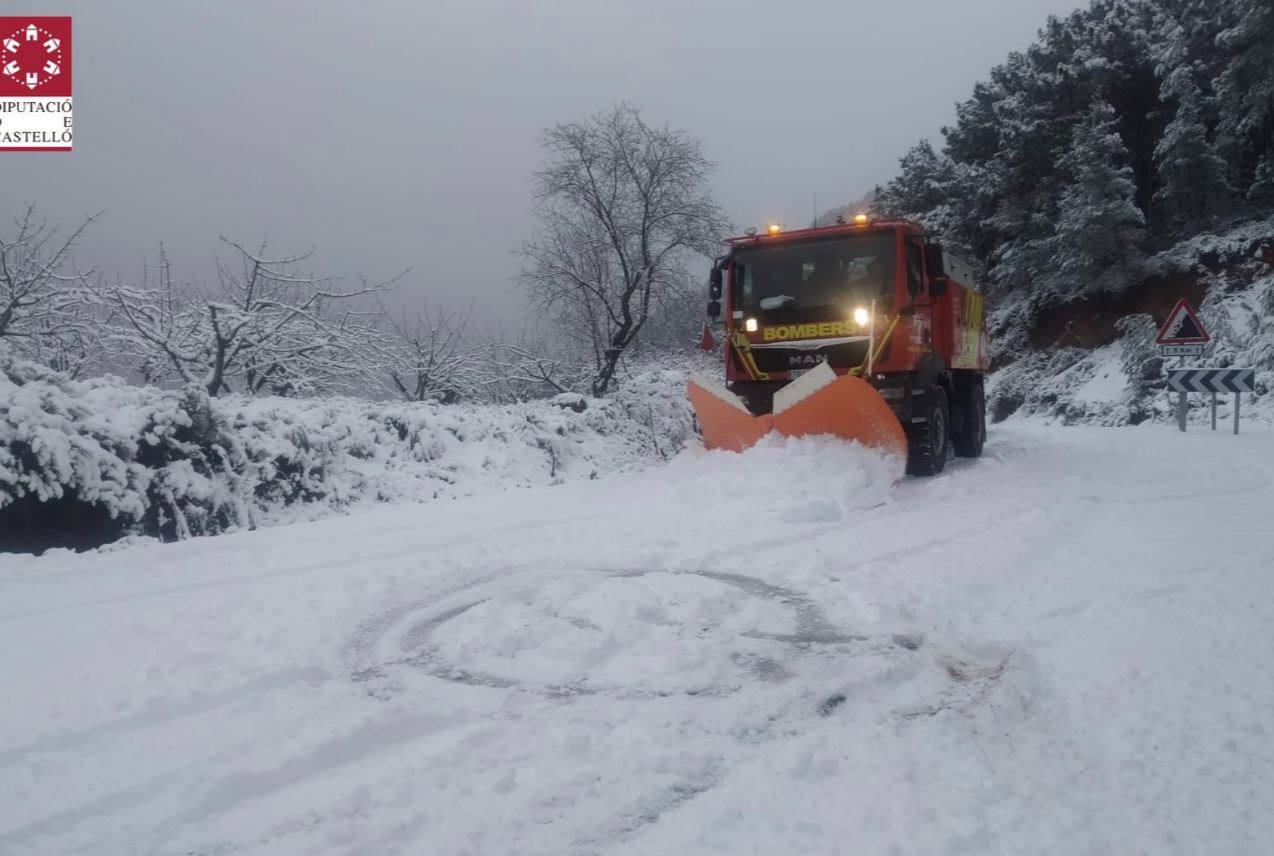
[{"x1": 7, "y1": 0, "x2": 1080, "y2": 317}]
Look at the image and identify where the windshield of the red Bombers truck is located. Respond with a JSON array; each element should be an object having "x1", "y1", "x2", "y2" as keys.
[{"x1": 734, "y1": 233, "x2": 897, "y2": 322}]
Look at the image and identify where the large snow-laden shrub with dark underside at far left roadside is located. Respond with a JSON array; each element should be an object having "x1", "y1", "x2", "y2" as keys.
[{"x1": 0, "y1": 352, "x2": 251, "y2": 545}]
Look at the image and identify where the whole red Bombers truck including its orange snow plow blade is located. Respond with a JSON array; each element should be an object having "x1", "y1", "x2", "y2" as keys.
[{"x1": 689, "y1": 214, "x2": 989, "y2": 475}]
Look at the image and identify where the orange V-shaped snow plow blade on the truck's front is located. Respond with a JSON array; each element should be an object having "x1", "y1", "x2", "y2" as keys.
[{"x1": 689, "y1": 364, "x2": 907, "y2": 457}]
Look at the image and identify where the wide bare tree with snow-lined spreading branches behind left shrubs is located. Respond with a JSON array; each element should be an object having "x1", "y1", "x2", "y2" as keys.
[{"x1": 112, "y1": 238, "x2": 392, "y2": 395}]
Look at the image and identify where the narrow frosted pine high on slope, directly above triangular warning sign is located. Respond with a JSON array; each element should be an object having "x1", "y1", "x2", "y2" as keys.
[{"x1": 1154, "y1": 65, "x2": 1235, "y2": 233}]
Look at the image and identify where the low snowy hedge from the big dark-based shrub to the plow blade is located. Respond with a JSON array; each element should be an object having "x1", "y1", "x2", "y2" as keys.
[{"x1": 217, "y1": 361, "x2": 692, "y2": 521}]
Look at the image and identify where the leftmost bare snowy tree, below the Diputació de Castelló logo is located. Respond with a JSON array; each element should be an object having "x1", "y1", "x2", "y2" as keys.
[{"x1": 0, "y1": 205, "x2": 103, "y2": 376}]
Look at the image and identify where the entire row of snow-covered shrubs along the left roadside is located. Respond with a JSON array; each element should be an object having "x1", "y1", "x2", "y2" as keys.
[{"x1": 0, "y1": 354, "x2": 692, "y2": 549}]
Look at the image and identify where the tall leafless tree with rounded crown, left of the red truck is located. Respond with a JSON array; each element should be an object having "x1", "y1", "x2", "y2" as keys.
[{"x1": 521, "y1": 106, "x2": 726, "y2": 395}]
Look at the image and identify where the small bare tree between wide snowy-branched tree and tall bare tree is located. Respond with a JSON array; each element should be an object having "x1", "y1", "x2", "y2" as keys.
[{"x1": 377, "y1": 301, "x2": 478, "y2": 404}]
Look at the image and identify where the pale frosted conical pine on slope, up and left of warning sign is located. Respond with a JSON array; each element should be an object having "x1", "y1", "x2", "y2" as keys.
[{"x1": 1033, "y1": 98, "x2": 1145, "y2": 306}]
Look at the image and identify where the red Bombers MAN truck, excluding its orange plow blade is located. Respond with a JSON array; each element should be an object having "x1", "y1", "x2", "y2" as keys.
[{"x1": 708, "y1": 215, "x2": 989, "y2": 474}]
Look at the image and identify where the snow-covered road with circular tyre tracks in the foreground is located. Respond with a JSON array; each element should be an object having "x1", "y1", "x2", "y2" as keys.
[{"x1": 0, "y1": 423, "x2": 1274, "y2": 856}]
